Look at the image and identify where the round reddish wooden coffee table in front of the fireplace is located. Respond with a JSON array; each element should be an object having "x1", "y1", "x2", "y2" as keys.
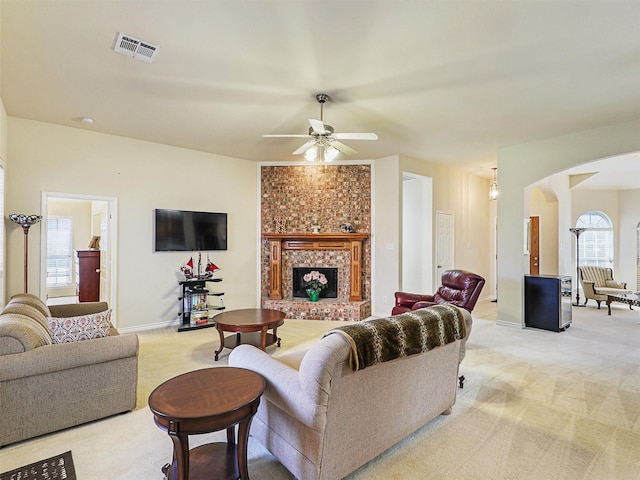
[{"x1": 214, "y1": 308, "x2": 286, "y2": 361}]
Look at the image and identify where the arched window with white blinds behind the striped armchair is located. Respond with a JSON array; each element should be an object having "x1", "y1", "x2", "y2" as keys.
[{"x1": 576, "y1": 211, "x2": 614, "y2": 268}]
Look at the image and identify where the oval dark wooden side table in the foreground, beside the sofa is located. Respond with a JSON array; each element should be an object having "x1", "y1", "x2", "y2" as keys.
[{"x1": 149, "y1": 367, "x2": 265, "y2": 480}]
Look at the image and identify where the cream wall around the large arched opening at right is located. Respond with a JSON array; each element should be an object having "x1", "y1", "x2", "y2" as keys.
[{"x1": 498, "y1": 121, "x2": 640, "y2": 326}]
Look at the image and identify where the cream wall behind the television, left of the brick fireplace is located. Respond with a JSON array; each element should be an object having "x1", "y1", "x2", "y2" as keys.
[{"x1": 6, "y1": 117, "x2": 258, "y2": 330}]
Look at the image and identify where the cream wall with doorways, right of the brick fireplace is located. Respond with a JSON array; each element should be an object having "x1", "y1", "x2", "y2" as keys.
[{"x1": 373, "y1": 156, "x2": 493, "y2": 316}]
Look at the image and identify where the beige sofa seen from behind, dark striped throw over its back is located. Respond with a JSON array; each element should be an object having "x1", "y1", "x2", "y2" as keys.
[{"x1": 229, "y1": 307, "x2": 471, "y2": 480}]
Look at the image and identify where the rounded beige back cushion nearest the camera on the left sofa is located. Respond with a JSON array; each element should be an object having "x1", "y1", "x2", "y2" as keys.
[{"x1": 0, "y1": 313, "x2": 51, "y2": 355}]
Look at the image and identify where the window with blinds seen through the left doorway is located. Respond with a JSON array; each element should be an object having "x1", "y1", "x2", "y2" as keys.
[{"x1": 47, "y1": 217, "x2": 73, "y2": 287}]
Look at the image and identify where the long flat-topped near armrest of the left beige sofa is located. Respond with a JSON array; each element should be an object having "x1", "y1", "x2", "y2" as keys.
[{"x1": 0, "y1": 334, "x2": 138, "y2": 382}]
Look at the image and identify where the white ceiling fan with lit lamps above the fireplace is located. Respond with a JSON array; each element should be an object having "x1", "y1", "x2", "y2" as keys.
[{"x1": 263, "y1": 93, "x2": 378, "y2": 162}]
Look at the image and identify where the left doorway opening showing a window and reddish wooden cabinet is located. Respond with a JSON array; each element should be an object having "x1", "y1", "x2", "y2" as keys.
[{"x1": 40, "y1": 192, "x2": 118, "y2": 326}]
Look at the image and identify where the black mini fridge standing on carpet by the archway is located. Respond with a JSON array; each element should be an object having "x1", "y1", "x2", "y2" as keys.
[{"x1": 524, "y1": 275, "x2": 571, "y2": 332}]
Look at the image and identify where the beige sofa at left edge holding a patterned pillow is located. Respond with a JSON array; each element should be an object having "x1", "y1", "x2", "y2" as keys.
[{"x1": 0, "y1": 294, "x2": 138, "y2": 446}]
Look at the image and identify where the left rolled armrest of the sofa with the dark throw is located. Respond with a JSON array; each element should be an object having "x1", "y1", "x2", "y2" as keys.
[{"x1": 229, "y1": 345, "x2": 318, "y2": 428}]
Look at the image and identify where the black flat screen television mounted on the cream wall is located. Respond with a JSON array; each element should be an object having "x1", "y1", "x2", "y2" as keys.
[{"x1": 154, "y1": 208, "x2": 227, "y2": 252}]
